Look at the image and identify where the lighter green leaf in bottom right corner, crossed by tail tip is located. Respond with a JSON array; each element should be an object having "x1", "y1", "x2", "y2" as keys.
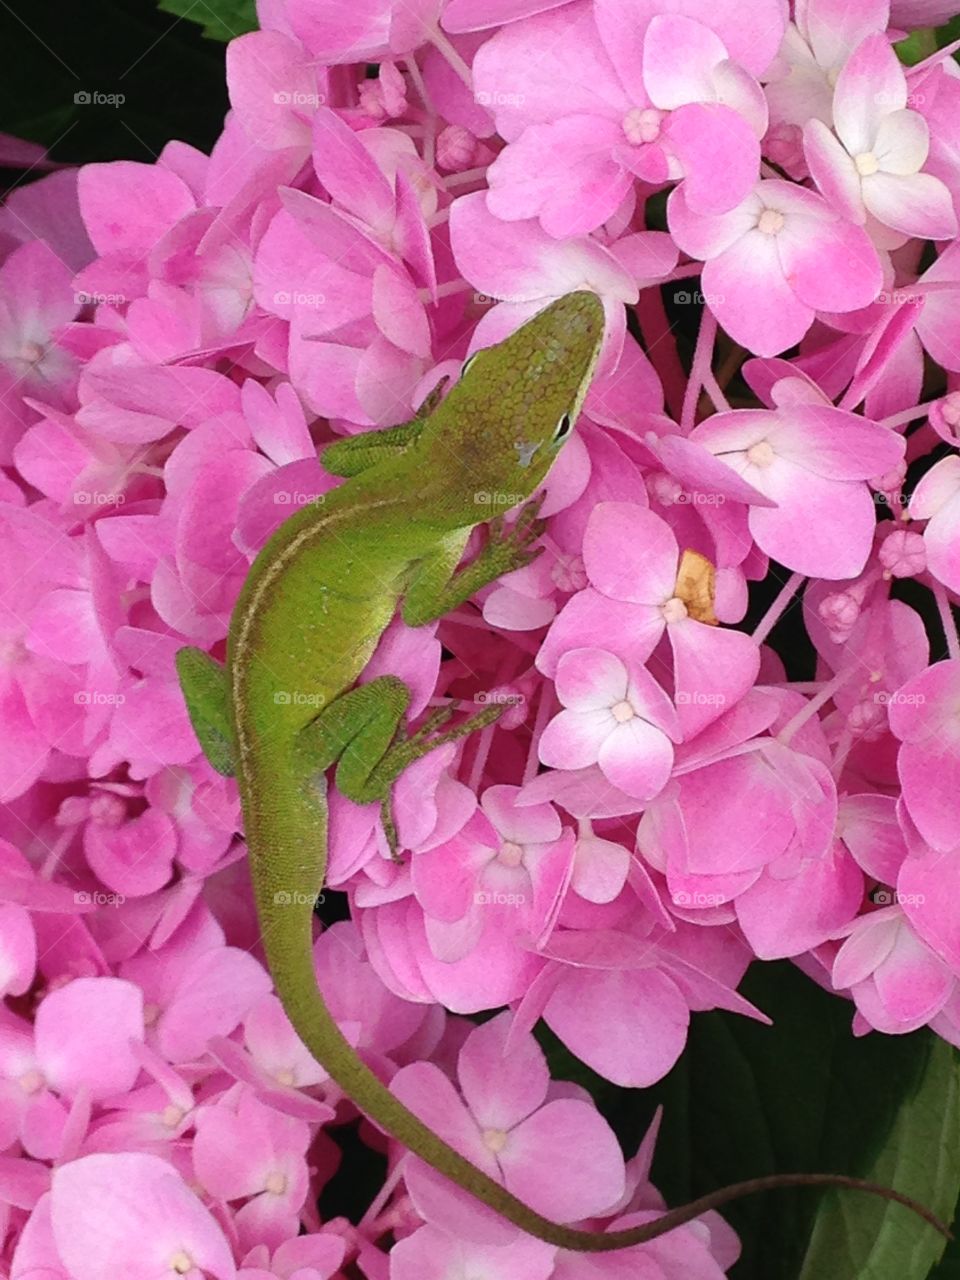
[{"x1": 799, "y1": 1041, "x2": 960, "y2": 1280}]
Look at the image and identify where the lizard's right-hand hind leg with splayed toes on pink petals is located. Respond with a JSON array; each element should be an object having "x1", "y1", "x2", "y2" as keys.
[{"x1": 297, "y1": 676, "x2": 504, "y2": 858}]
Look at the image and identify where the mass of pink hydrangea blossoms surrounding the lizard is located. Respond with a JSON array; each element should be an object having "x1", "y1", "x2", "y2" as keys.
[{"x1": 0, "y1": 0, "x2": 960, "y2": 1280}]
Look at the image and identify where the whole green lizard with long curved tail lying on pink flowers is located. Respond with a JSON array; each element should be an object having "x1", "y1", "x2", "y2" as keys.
[{"x1": 178, "y1": 292, "x2": 952, "y2": 1251}]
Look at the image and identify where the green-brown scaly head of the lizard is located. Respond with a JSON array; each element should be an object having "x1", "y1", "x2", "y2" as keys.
[{"x1": 424, "y1": 291, "x2": 604, "y2": 524}]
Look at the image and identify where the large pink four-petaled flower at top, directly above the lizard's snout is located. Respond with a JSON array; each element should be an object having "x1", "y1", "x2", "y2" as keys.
[{"x1": 475, "y1": 4, "x2": 767, "y2": 239}]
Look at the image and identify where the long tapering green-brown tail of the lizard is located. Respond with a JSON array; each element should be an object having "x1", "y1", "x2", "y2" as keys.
[{"x1": 241, "y1": 772, "x2": 950, "y2": 1253}]
